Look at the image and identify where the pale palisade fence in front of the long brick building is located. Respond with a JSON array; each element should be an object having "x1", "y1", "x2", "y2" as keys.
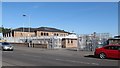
[{"x1": 4, "y1": 36, "x2": 62, "y2": 49}]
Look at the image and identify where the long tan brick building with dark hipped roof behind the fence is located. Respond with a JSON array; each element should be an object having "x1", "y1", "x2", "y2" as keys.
[{"x1": 3, "y1": 27, "x2": 69, "y2": 37}]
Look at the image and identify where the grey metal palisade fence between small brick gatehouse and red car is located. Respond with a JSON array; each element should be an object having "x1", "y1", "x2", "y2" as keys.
[{"x1": 78, "y1": 33, "x2": 112, "y2": 51}]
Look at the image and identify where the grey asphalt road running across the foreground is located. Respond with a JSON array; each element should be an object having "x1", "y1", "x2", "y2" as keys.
[{"x1": 2, "y1": 46, "x2": 118, "y2": 66}]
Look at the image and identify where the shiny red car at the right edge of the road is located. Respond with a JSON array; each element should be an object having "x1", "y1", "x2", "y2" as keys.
[{"x1": 94, "y1": 44, "x2": 120, "y2": 59}]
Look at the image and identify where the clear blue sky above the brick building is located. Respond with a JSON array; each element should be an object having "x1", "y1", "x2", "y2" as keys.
[{"x1": 2, "y1": 2, "x2": 118, "y2": 35}]
